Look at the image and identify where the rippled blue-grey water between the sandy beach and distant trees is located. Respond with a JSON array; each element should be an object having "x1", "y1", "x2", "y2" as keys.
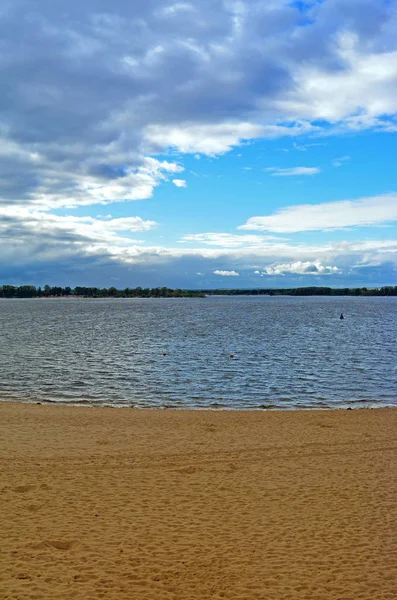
[{"x1": 0, "y1": 296, "x2": 397, "y2": 409}]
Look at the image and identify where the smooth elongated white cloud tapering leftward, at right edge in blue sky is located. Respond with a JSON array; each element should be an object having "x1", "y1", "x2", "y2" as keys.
[{"x1": 238, "y1": 193, "x2": 397, "y2": 233}]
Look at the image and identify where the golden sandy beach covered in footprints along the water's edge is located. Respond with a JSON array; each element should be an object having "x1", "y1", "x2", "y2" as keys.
[{"x1": 0, "y1": 403, "x2": 397, "y2": 600}]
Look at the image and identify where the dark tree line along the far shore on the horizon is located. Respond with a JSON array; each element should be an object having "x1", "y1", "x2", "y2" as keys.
[{"x1": 0, "y1": 285, "x2": 397, "y2": 298}]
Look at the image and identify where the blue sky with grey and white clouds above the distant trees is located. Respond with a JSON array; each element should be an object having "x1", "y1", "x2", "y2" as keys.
[{"x1": 0, "y1": 0, "x2": 397, "y2": 289}]
